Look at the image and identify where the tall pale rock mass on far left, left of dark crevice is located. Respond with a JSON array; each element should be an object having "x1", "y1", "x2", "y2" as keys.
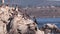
[{"x1": 0, "y1": 6, "x2": 14, "y2": 34}]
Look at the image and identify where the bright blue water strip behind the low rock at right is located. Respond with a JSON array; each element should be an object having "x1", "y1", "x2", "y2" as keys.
[{"x1": 36, "y1": 18, "x2": 60, "y2": 28}]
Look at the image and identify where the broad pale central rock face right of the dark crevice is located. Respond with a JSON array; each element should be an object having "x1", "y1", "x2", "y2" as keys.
[{"x1": 11, "y1": 11, "x2": 34, "y2": 33}]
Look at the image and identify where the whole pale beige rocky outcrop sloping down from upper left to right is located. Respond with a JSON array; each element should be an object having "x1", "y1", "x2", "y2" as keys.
[{"x1": 0, "y1": 5, "x2": 60, "y2": 34}]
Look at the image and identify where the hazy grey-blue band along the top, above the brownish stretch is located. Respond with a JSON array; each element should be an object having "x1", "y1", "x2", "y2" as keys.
[{"x1": 2, "y1": 0, "x2": 60, "y2": 7}]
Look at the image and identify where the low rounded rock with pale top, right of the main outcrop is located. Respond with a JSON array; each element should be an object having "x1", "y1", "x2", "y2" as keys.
[{"x1": 41, "y1": 23, "x2": 60, "y2": 34}]
